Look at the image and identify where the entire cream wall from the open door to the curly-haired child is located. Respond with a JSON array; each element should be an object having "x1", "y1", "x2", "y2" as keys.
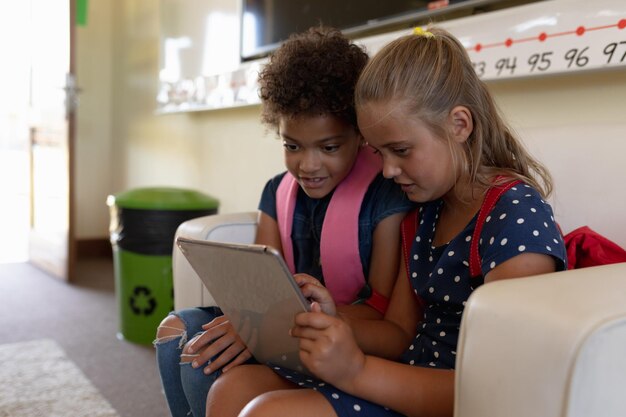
[{"x1": 76, "y1": 0, "x2": 282, "y2": 239}]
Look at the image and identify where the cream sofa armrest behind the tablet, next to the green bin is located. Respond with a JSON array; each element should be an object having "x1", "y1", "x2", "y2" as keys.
[{"x1": 172, "y1": 212, "x2": 258, "y2": 310}]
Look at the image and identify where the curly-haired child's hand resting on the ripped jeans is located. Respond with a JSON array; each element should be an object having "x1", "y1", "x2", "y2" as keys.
[{"x1": 185, "y1": 316, "x2": 252, "y2": 375}]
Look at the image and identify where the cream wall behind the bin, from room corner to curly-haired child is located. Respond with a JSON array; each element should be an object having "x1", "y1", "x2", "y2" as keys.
[{"x1": 106, "y1": 0, "x2": 282, "y2": 212}]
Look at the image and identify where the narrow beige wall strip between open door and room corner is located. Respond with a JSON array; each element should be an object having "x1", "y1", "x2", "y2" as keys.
[{"x1": 74, "y1": 1, "x2": 115, "y2": 238}]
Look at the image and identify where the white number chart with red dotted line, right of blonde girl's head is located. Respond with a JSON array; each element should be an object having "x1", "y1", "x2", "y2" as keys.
[{"x1": 444, "y1": 0, "x2": 626, "y2": 80}]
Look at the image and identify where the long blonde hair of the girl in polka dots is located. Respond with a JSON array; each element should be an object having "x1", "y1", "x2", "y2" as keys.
[{"x1": 355, "y1": 28, "x2": 552, "y2": 198}]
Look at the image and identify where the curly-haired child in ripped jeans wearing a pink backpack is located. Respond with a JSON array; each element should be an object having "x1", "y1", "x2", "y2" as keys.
[{"x1": 155, "y1": 27, "x2": 413, "y2": 417}]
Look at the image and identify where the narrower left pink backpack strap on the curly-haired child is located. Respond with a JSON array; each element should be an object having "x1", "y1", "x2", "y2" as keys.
[{"x1": 276, "y1": 172, "x2": 300, "y2": 274}]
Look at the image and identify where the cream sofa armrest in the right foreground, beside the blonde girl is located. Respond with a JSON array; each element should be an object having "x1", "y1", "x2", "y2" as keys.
[{"x1": 454, "y1": 263, "x2": 626, "y2": 417}]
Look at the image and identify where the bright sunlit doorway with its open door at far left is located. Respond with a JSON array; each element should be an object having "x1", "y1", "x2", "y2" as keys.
[{"x1": 0, "y1": 0, "x2": 74, "y2": 280}]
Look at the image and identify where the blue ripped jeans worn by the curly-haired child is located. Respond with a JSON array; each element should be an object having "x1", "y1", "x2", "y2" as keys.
[{"x1": 154, "y1": 307, "x2": 222, "y2": 417}]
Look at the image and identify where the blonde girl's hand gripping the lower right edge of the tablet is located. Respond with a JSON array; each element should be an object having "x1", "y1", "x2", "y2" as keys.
[{"x1": 291, "y1": 302, "x2": 365, "y2": 389}]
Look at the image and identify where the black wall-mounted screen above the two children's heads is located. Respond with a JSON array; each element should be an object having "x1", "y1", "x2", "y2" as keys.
[{"x1": 241, "y1": 0, "x2": 497, "y2": 60}]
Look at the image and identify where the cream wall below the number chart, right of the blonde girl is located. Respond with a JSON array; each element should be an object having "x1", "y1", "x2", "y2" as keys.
[{"x1": 490, "y1": 68, "x2": 626, "y2": 247}]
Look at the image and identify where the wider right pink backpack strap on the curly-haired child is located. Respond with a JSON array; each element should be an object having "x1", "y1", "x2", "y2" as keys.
[{"x1": 320, "y1": 146, "x2": 382, "y2": 304}]
